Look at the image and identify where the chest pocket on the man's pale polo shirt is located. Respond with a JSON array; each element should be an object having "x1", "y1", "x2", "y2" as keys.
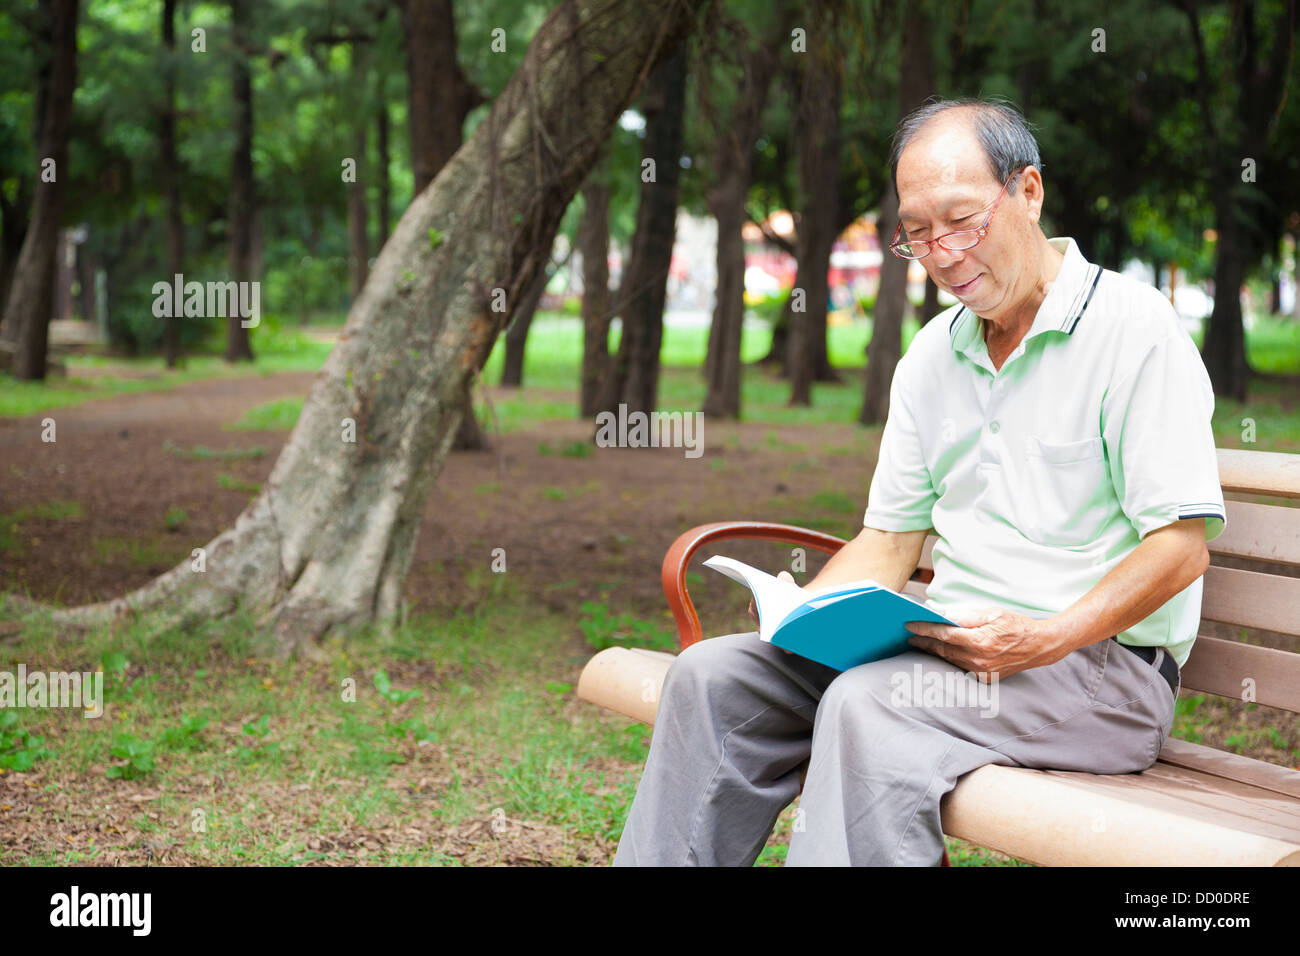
[{"x1": 1015, "y1": 436, "x2": 1114, "y2": 548}]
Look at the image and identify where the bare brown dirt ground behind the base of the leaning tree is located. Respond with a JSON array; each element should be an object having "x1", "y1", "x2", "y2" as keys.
[{"x1": 0, "y1": 373, "x2": 878, "y2": 627}]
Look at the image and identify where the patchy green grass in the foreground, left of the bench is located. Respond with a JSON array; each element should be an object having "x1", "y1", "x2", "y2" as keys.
[{"x1": 0, "y1": 582, "x2": 1040, "y2": 866}]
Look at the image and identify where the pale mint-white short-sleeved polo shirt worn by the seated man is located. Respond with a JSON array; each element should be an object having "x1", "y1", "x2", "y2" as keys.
[{"x1": 862, "y1": 238, "x2": 1226, "y2": 666}]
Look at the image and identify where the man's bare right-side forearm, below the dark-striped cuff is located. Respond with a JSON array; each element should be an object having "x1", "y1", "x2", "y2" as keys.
[{"x1": 1043, "y1": 519, "x2": 1209, "y2": 653}]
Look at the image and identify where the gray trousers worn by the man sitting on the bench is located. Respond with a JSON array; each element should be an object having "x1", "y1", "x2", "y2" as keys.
[{"x1": 614, "y1": 632, "x2": 1174, "y2": 866}]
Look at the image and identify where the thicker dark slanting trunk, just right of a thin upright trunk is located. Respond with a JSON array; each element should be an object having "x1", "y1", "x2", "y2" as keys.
[{"x1": 601, "y1": 38, "x2": 686, "y2": 415}]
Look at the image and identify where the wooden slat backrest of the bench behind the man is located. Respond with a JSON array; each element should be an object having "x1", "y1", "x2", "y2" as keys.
[{"x1": 905, "y1": 449, "x2": 1300, "y2": 714}]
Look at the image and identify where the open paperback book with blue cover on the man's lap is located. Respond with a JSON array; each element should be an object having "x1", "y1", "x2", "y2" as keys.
[{"x1": 705, "y1": 554, "x2": 956, "y2": 671}]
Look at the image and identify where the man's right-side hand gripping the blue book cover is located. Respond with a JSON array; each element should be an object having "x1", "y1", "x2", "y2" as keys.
[{"x1": 904, "y1": 607, "x2": 1070, "y2": 683}]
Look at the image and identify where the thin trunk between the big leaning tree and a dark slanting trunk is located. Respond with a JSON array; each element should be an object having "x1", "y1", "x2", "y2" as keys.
[{"x1": 577, "y1": 161, "x2": 610, "y2": 419}]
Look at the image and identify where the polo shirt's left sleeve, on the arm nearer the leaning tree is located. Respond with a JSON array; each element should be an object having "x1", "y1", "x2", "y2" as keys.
[{"x1": 862, "y1": 355, "x2": 939, "y2": 531}]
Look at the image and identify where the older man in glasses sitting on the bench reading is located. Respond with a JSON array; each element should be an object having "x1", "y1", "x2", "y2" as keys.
[{"x1": 614, "y1": 100, "x2": 1226, "y2": 865}]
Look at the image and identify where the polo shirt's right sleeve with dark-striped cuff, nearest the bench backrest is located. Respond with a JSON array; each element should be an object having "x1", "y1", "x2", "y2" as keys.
[{"x1": 1101, "y1": 326, "x2": 1227, "y2": 541}]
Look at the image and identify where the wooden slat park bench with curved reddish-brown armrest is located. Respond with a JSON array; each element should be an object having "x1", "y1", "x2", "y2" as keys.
[{"x1": 577, "y1": 449, "x2": 1300, "y2": 866}]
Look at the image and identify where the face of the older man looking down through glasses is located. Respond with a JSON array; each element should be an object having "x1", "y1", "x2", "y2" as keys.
[{"x1": 898, "y1": 120, "x2": 1031, "y2": 320}]
